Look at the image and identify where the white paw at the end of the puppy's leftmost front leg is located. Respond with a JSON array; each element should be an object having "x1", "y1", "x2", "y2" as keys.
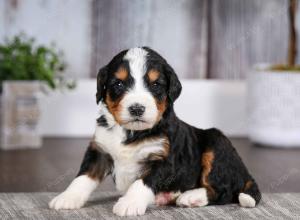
[{"x1": 49, "y1": 191, "x2": 87, "y2": 210}]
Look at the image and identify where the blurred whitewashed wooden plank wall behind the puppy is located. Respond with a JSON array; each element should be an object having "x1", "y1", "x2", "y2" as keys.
[{"x1": 0, "y1": 0, "x2": 300, "y2": 79}]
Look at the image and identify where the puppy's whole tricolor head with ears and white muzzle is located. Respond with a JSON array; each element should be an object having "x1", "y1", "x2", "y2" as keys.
[{"x1": 96, "y1": 47, "x2": 181, "y2": 130}]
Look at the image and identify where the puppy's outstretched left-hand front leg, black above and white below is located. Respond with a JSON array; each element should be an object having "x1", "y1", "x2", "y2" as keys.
[{"x1": 49, "y1": 142, "x2": 113, "y2": 209}]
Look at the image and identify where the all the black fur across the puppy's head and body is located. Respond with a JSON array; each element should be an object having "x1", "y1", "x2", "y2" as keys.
[{"x1": 89, "y1": 47, "x2": 261, "y2": 204}]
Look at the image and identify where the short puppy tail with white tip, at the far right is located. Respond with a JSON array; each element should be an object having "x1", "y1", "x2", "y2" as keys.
[{"x1": 239, "y1": 180, "x2": 261, "y2": 208}]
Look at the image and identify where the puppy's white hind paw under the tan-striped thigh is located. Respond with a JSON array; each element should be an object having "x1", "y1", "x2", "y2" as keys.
[{"x1": 176, "y1": 188, "x2": 208, "y2": 207}]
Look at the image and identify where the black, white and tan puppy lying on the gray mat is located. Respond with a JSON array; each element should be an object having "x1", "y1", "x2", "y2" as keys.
[{"x1": 49, "y1": 47, "x2": 261, "y2": 216}]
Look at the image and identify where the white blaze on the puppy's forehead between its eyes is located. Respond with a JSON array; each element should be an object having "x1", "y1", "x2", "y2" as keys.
[{"x1": 124, "y1": 47, "x2": 148, "y2": 91}]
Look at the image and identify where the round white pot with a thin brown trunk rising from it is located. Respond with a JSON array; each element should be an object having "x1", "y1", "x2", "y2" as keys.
[{"x1": 248, "y1": 0, "x2": 300, "y2": 147}]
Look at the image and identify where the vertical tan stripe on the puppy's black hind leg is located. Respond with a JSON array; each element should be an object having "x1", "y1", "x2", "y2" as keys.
[{"x1": 201, "y1": 151, "x2": 215, "y2": 197}]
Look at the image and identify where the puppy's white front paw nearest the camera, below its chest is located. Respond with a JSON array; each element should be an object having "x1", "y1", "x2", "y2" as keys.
[{"x1": 113, "y1": 196, "x2": 147, "y2": 216}]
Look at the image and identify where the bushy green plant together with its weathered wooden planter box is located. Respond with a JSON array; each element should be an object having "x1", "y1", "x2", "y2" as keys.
[{"x1": 0, "y1": 34, "x2": 74, "y2": 149}]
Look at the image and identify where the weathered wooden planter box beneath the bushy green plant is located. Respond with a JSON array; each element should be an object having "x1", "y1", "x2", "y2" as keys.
[{"x1": 0, "y1": 81, "x2": 42, "y2": 150}]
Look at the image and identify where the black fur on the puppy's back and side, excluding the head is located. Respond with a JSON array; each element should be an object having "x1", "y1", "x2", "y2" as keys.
[{"x1": 144, "y1": 112, "x2": 261, "y2": 204}]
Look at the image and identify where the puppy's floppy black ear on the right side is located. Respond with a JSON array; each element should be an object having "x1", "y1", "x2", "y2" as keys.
[{"x1": 165, "y1": 64, "x2": 182, "y2": 103}]
